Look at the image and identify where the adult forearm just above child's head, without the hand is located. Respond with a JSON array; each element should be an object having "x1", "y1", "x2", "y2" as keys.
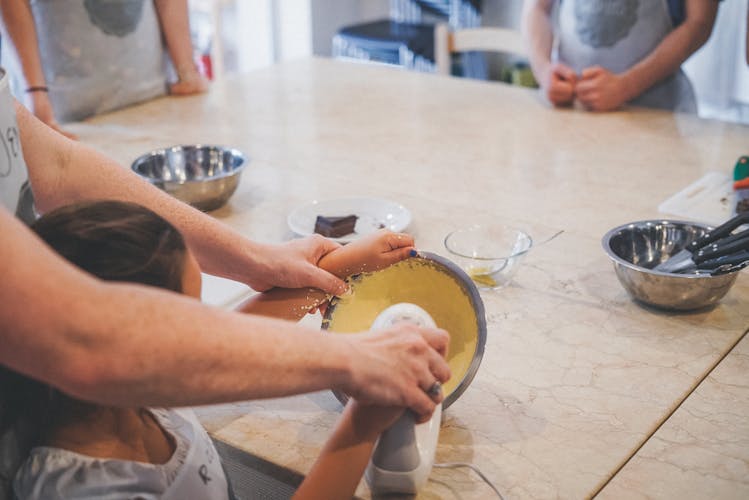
[{"x1": 16, "y1": 99, "x2": 268, "y2": 283}]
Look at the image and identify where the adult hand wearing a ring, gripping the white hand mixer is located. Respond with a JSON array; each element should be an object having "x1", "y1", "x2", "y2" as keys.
[{"x1": 336, "y1": 322, "x2": 450, "y2": 422}]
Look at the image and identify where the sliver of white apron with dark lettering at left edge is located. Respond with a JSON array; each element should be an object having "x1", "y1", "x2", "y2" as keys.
[{"x1": 0, "y1": 68, "x2": 36, "y2": 224}]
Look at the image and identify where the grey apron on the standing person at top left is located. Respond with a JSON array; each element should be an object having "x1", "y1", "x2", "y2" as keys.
[{"x1": 31, "y1": 0, "x2": 167, "y2": 122}]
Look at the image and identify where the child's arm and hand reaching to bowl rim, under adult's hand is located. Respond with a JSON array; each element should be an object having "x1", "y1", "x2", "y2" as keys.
[{"x1": 237, "y1": 230, "x2": 414, "y2": 320}]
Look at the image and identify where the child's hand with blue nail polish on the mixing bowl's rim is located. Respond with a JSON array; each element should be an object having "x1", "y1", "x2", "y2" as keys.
[{"x1": 318, "y1": 229, "x2": 415, "y2": 278}]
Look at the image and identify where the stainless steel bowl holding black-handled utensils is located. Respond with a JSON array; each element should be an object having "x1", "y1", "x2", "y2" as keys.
[{"x1": 602, "y1": 220, "x2": 738, "y2": 311}]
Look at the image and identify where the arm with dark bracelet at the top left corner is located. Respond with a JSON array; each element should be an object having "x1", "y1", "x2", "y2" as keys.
[{"x1": 0, "y1": 0, "x2": 76, "y2": 139}]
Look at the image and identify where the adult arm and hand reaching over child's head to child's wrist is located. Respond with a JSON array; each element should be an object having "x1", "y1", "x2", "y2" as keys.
[{"x1": 15, "y1": 102, "x2": 345, "y2": 294}]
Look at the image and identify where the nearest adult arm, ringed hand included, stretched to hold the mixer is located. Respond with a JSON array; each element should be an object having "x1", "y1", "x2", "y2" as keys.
[{"x1": 0, "y1": 205, "x2": 449, "y2": 415}]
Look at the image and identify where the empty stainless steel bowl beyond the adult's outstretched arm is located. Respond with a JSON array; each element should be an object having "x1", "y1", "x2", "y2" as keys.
[{"x1": 132, "y1": 145, "x2": 246, "y2": 211}]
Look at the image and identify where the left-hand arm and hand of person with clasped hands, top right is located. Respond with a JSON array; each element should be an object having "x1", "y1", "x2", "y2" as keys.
[{"x1": 523, "y1": 0, "x2": 577, "y2": 106}]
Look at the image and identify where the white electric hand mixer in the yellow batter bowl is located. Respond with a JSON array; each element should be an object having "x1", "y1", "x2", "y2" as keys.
[{"x1": 365, "y1": 302, "x2": 442, "y2": 495}]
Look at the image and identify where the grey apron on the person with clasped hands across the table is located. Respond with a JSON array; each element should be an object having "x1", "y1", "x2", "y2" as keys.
[{"x1": 558, "y1": 0, "x2": 697, "y2": 113}]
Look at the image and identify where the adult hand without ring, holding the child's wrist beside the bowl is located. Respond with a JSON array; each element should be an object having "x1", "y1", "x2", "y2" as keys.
[{"x1": 246, "y1": 234, "x2": 346, "y2": 295}]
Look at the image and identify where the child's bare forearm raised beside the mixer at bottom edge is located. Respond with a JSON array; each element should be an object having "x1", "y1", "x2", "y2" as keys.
[{"x1": 293, "y1": 399, "x2": 403, "y2": 500}]
